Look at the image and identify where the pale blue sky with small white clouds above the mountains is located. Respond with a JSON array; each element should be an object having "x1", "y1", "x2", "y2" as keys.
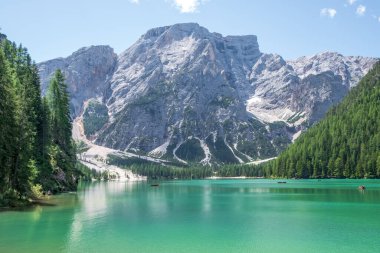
[{"x1": 0, "y1": 0, "x2": 380, "y2": 62}]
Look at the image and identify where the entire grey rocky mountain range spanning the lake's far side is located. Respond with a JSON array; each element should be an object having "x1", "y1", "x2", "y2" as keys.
[{"x1": 39, "y1": 23, "x2": 376, "y2": 164}]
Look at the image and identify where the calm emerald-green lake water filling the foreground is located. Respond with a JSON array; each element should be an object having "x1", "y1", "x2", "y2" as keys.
[{"x1": 0, "y1": 180, "x2": 380, "y2": 253}]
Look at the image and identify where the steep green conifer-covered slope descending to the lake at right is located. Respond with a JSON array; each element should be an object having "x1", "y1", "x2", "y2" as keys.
[{"x1": 269, "y1": 62, "x2": 380, "y2": 178}]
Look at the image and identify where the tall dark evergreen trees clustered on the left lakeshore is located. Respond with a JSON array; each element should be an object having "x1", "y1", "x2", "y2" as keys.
[{"x1": 0, "y1": 35, "x2": 77, "y2": 206}]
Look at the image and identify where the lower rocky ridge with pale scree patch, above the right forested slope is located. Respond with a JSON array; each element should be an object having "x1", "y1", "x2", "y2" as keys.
[{"x1": 247, "y1": 52, "x2": 377, "y2": 126}]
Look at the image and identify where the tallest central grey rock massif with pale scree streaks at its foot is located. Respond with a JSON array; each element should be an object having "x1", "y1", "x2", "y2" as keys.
[{"x1": 96, "y1": 24, "x2": 277, "y2": 163}]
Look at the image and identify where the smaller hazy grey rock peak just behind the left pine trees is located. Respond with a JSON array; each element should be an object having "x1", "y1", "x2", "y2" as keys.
[{"x1": 38, "y1": 46, "x2": 117, "y2": 117}]
